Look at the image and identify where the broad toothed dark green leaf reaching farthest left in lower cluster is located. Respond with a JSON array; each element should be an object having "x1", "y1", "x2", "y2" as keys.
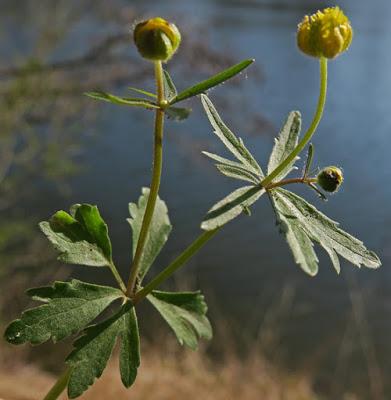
[{"x1": 4, "y1": 280, "x2": 123, "y2": 345}]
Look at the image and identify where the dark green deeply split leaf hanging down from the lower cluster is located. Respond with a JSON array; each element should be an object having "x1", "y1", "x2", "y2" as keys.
[{"x1": 66, "y1": 302, "x2": 140, "y2": 399}]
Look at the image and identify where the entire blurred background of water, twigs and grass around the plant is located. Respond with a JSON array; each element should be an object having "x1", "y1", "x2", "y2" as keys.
[{"x1": 0, "y1": 0, "x2": 391, "y2": 400}]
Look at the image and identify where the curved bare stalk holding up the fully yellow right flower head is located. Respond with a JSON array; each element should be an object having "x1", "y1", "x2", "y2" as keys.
[{"x1": 261, "y1": 57, "x2": 327, "y2": 187}]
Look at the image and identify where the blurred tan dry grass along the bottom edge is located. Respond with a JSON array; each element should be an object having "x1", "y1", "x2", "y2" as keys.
[{"x1": 0, "y1": 346, "x2": 317, "y2": 400}]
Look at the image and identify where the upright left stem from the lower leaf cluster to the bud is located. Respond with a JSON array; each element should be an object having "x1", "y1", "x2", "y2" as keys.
[{"x1": 126, "y1": 61, "x2": 165, "y2": 296}]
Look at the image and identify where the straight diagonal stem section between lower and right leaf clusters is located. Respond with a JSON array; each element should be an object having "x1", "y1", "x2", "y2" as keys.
[{"x1": 133, "y1": 228, "x2": 221, "y2": 303}]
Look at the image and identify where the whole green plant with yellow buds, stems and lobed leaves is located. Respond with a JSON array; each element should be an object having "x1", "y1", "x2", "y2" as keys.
[{"x1": 4, "y1": 7, "x2": 381, "y2": 400}]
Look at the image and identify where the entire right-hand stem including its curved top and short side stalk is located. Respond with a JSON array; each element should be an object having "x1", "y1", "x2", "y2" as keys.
[{"x1": 133, "y1": 57, "x2": 327, "y2": 303}]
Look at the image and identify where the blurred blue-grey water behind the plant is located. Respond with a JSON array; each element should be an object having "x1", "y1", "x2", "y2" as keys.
[{"x1": 3, "y1": 0, "x2": 391, "y2": 396}]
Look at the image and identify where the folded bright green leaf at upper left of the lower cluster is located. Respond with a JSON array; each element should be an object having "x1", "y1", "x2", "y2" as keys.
[{"x1": 39, "y1": 204, "x2": 112, "y2": 267}]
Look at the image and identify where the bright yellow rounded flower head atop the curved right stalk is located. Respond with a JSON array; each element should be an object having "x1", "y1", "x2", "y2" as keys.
[{"x1": 297, "y1": 7, "x2": 353, "y2": 58}]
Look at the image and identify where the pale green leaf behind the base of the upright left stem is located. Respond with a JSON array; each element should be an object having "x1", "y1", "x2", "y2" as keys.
[{"x1": 127, "y1": 188, "x2": 172, "y2": 283}]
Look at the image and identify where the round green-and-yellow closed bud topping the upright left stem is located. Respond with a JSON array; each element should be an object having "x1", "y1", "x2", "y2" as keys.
[{"x1": 133, "y1": 17, "x2": 181, "y2": 61}]
